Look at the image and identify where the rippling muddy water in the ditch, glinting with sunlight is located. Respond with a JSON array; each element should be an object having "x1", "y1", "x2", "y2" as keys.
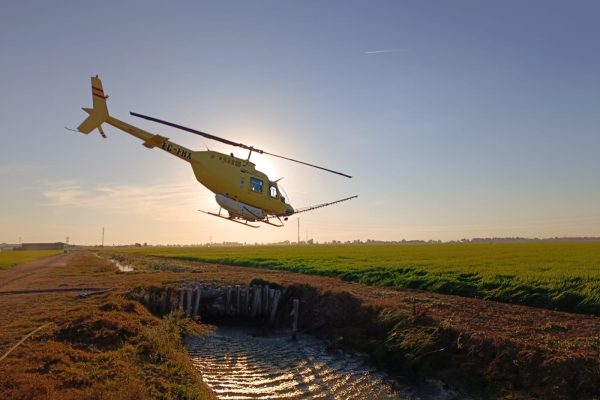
[{"x1": 186, "y1": 327, "x2": 460, "y2": 400}]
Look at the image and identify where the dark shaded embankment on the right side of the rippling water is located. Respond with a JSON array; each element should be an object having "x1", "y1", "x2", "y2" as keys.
[{"x1": 276, "y1": 285, "x2": 600, "y2": 400}]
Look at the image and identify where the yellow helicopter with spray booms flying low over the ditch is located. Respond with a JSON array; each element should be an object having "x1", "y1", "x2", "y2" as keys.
[{"x1": 77, "y1": 75, "x2": 358, "y2": 228}]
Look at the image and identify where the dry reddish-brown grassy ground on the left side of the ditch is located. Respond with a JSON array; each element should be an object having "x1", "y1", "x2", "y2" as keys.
[{"x1": 0, "y1": 253, "x2": 213, "y2": 399}]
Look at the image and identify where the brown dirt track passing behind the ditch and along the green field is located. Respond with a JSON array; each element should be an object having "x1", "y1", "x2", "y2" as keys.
[{"x1": 0, "y1": 248, "x2": 600, "y2": 398}]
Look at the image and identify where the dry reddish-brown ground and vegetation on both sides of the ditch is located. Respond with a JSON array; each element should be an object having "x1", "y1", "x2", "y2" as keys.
[{"x1": 0, "y1": 252, "x2": 600, "y2": 399}]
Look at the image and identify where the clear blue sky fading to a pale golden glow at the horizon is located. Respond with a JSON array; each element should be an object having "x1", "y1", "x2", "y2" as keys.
[{"x1": 0, "y1": 0, "x2": 600, "y2": 245}]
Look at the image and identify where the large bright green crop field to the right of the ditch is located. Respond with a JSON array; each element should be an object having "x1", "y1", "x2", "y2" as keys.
[{"x1": 117, "y1": 242, "x2": 600, "y2": 315}]
